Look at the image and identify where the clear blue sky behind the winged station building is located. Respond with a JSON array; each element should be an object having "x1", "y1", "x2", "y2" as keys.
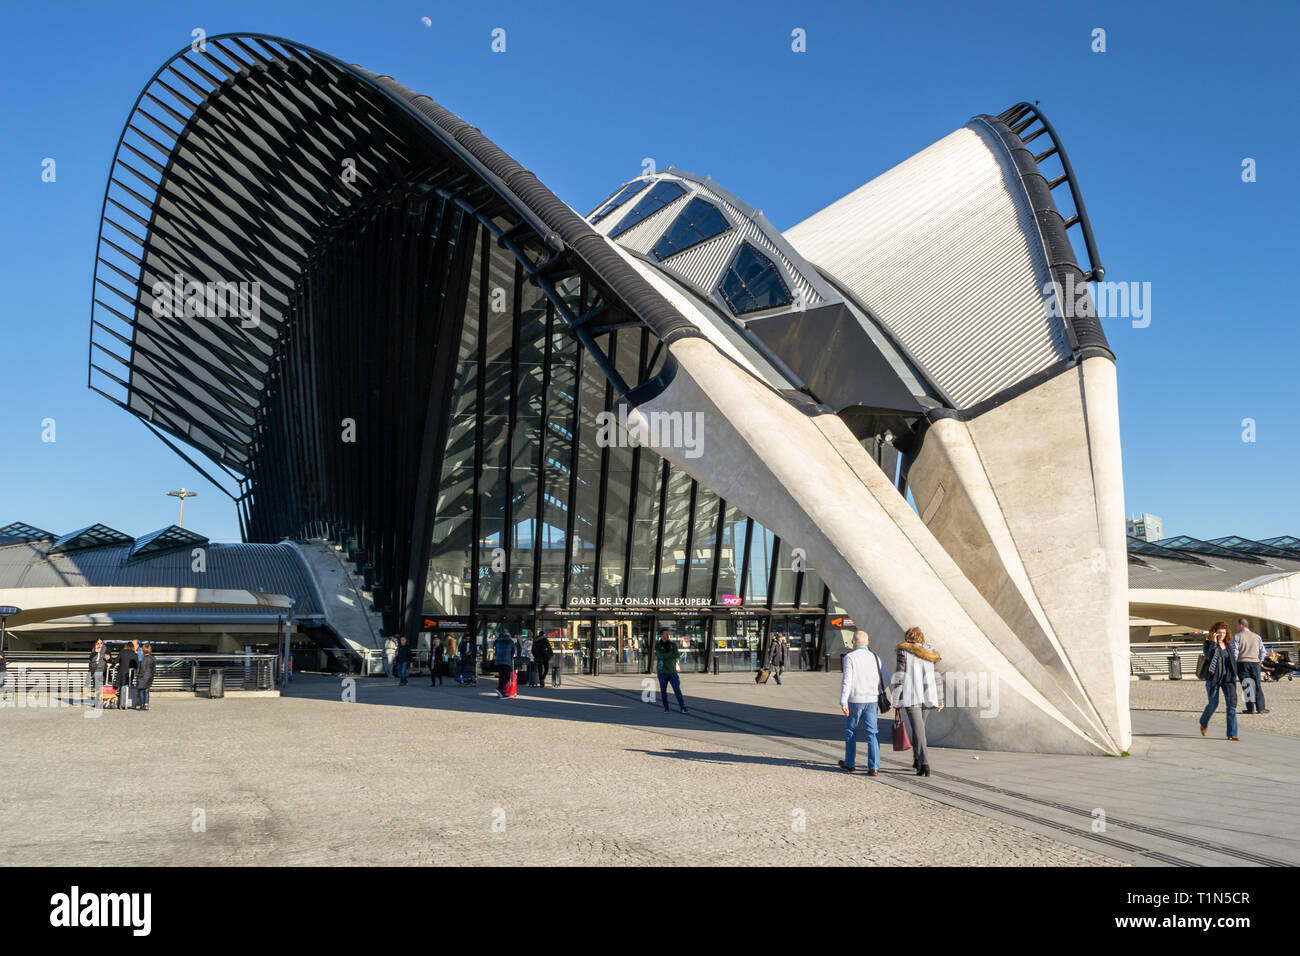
[{"x1": 0, "y1": 0, "x2": 1300, "y2": 540}]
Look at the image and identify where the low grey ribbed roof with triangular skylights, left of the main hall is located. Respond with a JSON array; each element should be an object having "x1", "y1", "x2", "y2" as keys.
[{"x1": 0, "y1": 542, "x2": 322, "y2": 617}]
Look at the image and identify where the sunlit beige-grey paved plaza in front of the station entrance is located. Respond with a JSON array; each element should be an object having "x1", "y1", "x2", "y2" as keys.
[{"x1": 0, "y1": 674, "x2": 1300, "y2": 866}]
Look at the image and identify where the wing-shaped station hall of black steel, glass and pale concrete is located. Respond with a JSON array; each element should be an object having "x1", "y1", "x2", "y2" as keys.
[{"x1": 88, "y1": 34, "x2": 1128, "y2": 752}]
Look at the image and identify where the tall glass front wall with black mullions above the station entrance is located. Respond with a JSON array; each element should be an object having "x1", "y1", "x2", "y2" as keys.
[{"x1": 424, "y1": 222, "x2": 827, "y2": 674}]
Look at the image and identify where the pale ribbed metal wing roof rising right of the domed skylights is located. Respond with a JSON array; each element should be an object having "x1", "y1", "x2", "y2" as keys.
[{"x1": 785, "y1": 122, "x2": 1073, "y2": 407}]
